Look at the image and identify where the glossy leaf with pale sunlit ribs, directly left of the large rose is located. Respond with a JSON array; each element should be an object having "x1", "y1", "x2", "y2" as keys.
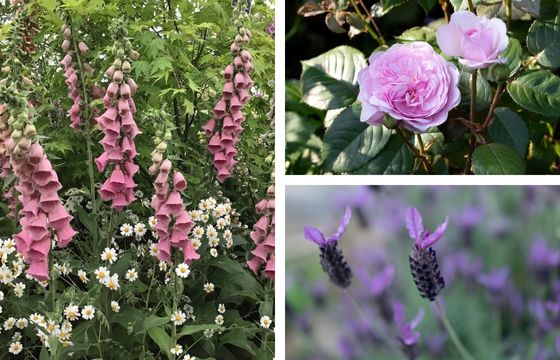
[{"x1": 301, "y1": 46, "x2": 366, "y2": 110}]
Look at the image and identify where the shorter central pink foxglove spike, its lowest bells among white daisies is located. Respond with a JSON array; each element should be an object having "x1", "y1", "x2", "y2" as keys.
[{"x1": 149, "y1": 111, "x2": 200, "y2": 264}]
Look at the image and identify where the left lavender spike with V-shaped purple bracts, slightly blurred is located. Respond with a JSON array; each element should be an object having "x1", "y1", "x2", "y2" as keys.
[{"x1": 303, "y1": 207, "x2": 352, "y2": 288}]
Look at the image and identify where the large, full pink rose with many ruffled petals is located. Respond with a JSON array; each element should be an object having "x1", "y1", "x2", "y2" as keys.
[{"x1": 358, "y1": 42, "x2": 461, "y2": 131}]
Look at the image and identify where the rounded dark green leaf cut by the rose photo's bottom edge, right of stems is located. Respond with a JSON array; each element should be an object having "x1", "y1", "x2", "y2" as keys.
[{"x1": 472, "y1": 143, "x2": 525, "y2": 175}]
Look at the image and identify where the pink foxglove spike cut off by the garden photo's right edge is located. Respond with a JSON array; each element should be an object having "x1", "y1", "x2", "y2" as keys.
[{"x1": 247, "y1": 185, "x2": 275, "y2": 280}]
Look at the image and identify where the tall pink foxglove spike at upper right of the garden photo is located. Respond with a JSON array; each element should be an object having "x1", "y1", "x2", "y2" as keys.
[{"x1": 202, "y1": 14, "x2": 253, "y2": 182}]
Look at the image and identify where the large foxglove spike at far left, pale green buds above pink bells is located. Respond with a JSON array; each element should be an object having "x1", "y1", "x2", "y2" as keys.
[{"x1": 0, "y1": 4, "x2": 76, "y2": 281}]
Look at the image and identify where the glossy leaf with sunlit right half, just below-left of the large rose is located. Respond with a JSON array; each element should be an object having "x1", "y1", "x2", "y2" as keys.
[{"x1": 322, "y1": 105, "x2": 391, "y2": 173}]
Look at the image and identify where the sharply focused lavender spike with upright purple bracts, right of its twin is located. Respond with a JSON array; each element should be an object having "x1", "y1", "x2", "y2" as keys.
[{"x1": 405, "y1": 208, "x2": 449, "y2": 301}]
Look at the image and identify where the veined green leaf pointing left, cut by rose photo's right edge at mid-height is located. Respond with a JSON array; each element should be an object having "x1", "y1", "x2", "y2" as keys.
[{"x1": 507, "y1": 70, "x2": 560, "y2": 117}]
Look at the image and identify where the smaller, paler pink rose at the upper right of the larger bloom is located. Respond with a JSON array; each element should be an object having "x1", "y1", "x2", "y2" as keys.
[{"x1": 437, "y1": 10, "x2": 509, "y2": 69}]
